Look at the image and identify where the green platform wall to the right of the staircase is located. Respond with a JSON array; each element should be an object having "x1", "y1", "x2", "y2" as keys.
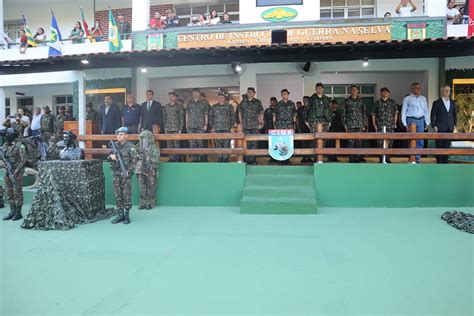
[{"x1": 314, "y1": 164, "x2": 474, "y2": 208}]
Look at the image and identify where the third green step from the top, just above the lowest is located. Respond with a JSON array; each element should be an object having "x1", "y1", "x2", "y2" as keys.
[{"x1": 242, "y1": 186, "x2": 316, "y2": 199}]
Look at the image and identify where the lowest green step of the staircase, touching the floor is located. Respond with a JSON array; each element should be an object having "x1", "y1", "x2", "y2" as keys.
[{"x1": 240, "y1": 198, "x2": 317, "y2": 214}]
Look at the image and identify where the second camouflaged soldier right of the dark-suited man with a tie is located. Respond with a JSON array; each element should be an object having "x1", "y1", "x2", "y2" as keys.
[{"x1": 186, "y1": 89, "x2": 209, "y2": 162}]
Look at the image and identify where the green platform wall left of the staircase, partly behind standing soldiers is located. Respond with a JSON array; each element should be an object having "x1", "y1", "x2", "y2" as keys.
[{"x1": 104, "y1": 163, "x2": 245, "y2": 206}]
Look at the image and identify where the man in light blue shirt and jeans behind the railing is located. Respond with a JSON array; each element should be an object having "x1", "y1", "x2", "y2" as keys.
[{"x1": 401, "y1": 82, "x2": 430, "y2": 163}]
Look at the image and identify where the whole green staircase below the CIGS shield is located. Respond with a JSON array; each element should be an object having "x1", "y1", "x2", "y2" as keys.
[{"x1": 240, "y1": 166, "x2": 317, "y2": 214}]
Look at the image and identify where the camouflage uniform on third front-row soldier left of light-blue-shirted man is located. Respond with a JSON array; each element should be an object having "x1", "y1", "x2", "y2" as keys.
[{"x1": 305, "y1": 93, "x2": 332, "y2": 133}]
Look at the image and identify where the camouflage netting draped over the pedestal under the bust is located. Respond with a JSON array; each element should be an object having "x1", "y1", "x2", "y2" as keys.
[{"x1": 21, "y1": 160, "x2": 115, "y2": 230}]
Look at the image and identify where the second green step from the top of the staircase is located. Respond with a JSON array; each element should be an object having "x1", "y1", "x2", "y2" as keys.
[{"x1": 245, "y1": 175, "x2": 314, "y2": 187}]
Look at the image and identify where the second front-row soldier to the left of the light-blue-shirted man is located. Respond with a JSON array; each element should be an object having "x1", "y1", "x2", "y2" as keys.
[{"x1": 342, "y1": 86, "x2": 367, "y2": 163}]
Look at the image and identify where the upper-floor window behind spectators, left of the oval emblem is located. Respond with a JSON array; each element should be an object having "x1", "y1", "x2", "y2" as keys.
[{"x1": 175, "y1": 2, "x2": 239, "y2": 26}]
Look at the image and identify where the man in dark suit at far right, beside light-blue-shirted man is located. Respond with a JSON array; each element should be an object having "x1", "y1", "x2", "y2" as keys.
[{"x1": 431, "y1": 85, "x2": 457, "y2": 163}]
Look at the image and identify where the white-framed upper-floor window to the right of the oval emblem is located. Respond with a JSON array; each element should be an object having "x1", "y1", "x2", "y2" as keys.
[{"x1": 320, "y1": 0, "x2": 376, "y2": 20}]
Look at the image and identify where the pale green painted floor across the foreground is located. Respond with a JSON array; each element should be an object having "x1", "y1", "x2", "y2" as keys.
[{"x1": 0, "y1": 207, "x2": 474, "y2": 316}]
